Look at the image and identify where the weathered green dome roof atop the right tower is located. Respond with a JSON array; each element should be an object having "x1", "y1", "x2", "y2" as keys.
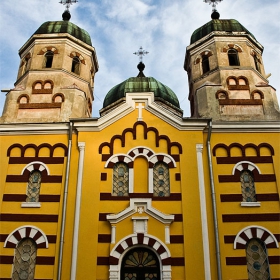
[{"x1": 191, "y1": 19, "x2": 256, "y2": 44}]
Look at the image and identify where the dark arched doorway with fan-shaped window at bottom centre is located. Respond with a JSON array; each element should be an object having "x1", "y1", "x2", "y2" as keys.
[{"x1": 121, "y1": 247, "x2": 161, "y2": 280}]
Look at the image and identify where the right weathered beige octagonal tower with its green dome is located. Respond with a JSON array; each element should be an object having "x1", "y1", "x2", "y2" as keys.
[{"x1": 184, "y1": 10, "x2": 280, "y2": 121}]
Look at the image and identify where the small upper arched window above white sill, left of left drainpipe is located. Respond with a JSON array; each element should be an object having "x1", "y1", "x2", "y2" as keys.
[{"x1": 26, "y1": 170, "x2": 42, "y2": 202}]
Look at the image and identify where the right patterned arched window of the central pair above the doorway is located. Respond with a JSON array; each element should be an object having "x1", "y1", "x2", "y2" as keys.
[{"x1": 153, "y1": 162, "x2": 170, "y2": 197}]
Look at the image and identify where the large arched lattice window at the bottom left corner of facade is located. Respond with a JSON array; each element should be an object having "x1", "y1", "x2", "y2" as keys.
[{"x1": 12, "y1": 238, "x2": 37, "y2": 280}]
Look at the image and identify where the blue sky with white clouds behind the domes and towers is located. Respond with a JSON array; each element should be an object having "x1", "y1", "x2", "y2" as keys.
[{"x1": 0, "y1": 0, "x2": 280, "y2": 117}]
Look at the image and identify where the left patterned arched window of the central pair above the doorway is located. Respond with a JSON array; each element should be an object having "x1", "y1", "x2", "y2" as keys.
[{"x1": 113, "y1": 162, "x2": 129, "y2": 196}]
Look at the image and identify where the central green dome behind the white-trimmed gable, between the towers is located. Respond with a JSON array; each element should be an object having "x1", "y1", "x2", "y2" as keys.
[{"x1": 103, "y1": 77, "x2": 180, "y2": 109}]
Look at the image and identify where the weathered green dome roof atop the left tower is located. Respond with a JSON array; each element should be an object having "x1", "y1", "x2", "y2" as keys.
[{"x1": 34, "y1": 20, "x2": 91, "y2": 46}]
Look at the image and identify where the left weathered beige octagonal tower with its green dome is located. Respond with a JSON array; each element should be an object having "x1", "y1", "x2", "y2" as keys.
[{"x1": 1, "y1": 10, "x2": 98, "y2": 123}]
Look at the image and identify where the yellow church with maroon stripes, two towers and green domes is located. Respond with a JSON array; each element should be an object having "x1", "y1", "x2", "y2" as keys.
[{"x1": 0, "y1": 0, "x2": 280, "y2": 280}]
